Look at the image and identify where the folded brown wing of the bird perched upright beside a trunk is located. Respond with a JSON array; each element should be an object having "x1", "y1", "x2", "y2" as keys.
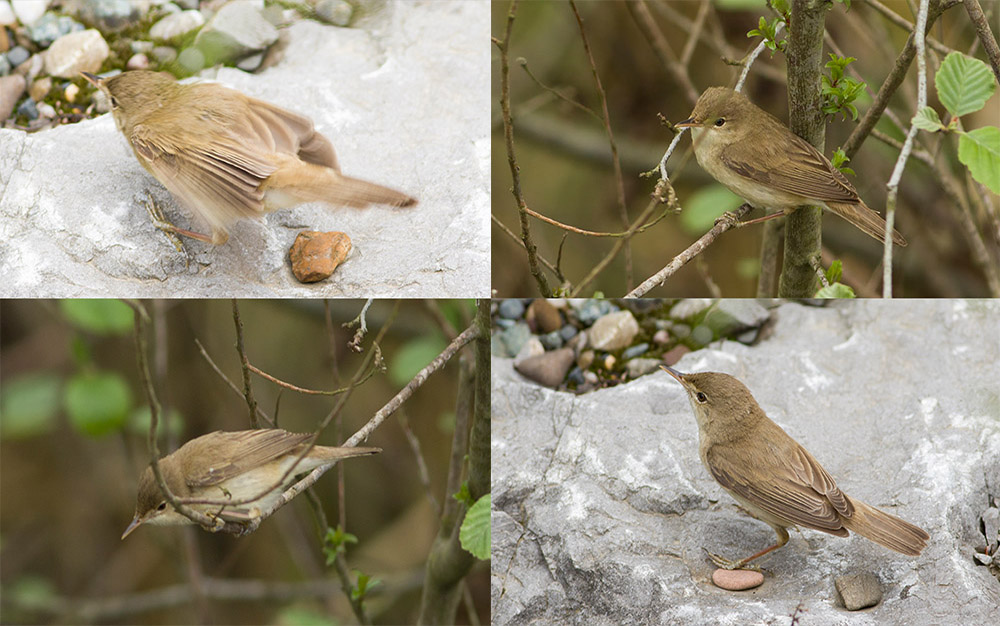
[{"x1": 720, "y1": 126, "x2": 859, "y2": 203}]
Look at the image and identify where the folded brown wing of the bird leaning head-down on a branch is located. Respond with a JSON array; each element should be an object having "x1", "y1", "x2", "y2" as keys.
[{"x1": 185, "y1": 428, "x2": 312, "y2": 488}]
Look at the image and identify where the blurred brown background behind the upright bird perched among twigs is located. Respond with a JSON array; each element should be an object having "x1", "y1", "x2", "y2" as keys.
[{"x1": 491, "y1": 0, "x2": 1000, "y2": 297}]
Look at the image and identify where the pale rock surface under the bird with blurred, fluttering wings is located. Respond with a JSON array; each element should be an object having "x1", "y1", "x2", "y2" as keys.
[{"x1": 0, "y1": 1, "x2": 490, "y2": 298}]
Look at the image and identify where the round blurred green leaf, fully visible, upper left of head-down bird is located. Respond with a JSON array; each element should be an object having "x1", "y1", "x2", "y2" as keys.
[{"x1": 63, "y1": 372, "x2": 132, "y2": 437}]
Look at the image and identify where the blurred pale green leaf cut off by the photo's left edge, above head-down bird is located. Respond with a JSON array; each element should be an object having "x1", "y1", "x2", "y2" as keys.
[{"x1": 0, "y1": 373, "x2": 62, "y2": 439}]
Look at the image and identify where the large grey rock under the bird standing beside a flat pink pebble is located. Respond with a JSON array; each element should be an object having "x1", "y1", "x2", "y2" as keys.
[{"x1": 490, "y1": 300, "x2": 1000, "y2": 626}]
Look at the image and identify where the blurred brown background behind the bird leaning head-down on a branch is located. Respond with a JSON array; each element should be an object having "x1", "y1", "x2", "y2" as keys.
[{"x1": 0, "y1": 300, "x2": 489, "y2": 624}]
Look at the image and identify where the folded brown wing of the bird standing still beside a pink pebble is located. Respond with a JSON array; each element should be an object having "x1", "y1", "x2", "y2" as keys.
[{"x1": 707, "y1": 441, "x2": 853, "y2": 536}]
